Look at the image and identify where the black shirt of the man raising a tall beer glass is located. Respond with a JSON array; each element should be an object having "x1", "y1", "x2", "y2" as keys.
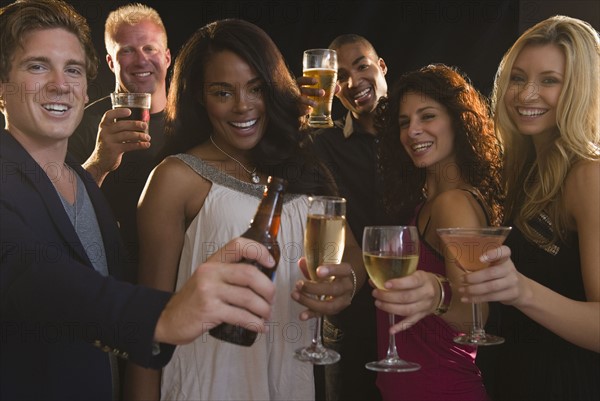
[{"x1": 313, "y1": 112, "x2": 389, "y2": 400}]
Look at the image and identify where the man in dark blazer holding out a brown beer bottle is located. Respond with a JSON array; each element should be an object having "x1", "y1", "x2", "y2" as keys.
[{"x1": 0, "y1": 0, "x2": 274, "y2": 400}]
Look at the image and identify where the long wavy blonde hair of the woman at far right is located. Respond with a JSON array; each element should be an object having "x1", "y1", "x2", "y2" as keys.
[{"x1": 492, "y1": 16, "x2": 600, "y2": 244}]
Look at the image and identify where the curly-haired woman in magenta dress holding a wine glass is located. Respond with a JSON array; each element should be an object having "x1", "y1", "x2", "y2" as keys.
[{"x1": 373, "y1": 65, "x2": 502, "y2": 401}]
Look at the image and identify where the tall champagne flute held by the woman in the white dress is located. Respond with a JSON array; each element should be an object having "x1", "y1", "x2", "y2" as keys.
[{"x1": 294, "y1": 196, "x2": 346, "y2": 365}]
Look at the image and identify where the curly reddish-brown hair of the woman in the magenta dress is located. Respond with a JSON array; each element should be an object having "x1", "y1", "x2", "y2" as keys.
[{"x1": 376, "y1": 64, "x2": 503, "y2": 225}]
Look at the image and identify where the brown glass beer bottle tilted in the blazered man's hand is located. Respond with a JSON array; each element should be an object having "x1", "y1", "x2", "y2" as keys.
[{"x1": 209, "y1": 177, "x2": 287, "y2": 347}]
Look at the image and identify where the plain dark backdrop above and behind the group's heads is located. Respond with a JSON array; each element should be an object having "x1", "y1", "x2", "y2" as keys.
[{"x1": 18, "y1": 0, "x2": 600, "y2": 117}]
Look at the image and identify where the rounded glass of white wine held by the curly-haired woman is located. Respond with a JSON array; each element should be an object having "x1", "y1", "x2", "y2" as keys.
[{"x1": 362, "y1": 226, "x2": 421, "y2": 372}]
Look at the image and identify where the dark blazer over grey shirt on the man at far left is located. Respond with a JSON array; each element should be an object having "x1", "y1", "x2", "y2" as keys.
[{"x1": 0, "y1": 129, "x2": 174, "y2": 400}]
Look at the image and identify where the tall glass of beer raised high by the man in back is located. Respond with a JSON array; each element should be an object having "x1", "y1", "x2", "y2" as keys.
[{"x1": 302, "y1": 49, "x2": 337, "y2": 128}]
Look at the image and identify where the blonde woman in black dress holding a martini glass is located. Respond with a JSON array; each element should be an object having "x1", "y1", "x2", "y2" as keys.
[{"x1": 466, "y1": 16, "x2": 600, "y2": 400}]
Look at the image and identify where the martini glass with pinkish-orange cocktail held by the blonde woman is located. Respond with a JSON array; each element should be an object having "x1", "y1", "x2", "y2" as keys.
[{"x1": 437, "y1": 227, "x2": 512, "y2": 345}]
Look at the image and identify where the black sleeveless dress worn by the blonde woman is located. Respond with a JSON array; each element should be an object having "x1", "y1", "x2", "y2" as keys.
[{"x1": 477, "y1": 217, "x2": 600, "y2": 400}]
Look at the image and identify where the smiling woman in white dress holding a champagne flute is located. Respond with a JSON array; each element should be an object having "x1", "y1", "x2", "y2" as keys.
[{"x1": 127, "y1": 19, "x2": 366, "y2": 400}]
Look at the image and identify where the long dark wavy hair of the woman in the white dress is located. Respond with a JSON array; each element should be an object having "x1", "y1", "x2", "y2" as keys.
[{"x1": 163, "y1": 19, "x2": 336, "y2": 195}]
